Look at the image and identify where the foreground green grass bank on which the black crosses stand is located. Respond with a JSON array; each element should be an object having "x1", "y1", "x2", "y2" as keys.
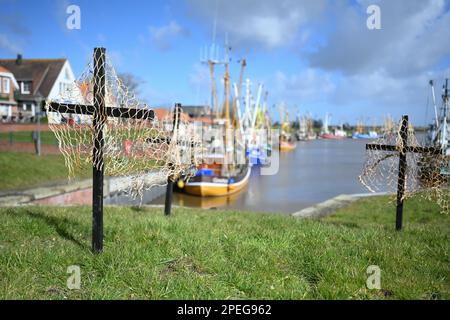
[{"x1": 0, "y1": 198, "x2": 450, "y2": 299}]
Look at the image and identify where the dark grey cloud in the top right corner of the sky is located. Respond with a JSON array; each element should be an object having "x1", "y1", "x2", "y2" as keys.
[{"x1": 309, "y1": 0, "x2": 450, "y2": 77}]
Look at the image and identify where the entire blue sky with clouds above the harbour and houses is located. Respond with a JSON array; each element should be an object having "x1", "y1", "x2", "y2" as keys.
[{"x1": 0, "y1": 0, "x2": 450, "y2": 124}]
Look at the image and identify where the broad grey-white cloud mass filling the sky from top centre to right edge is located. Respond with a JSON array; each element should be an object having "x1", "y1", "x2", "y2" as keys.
[{"x1": 188, "y1": 0, "x2": 450, "y2": 123}]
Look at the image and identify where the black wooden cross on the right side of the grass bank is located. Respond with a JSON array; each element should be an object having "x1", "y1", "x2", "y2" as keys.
[{"x1": 366, "y1": 115, "x2": 441, "y2": 230}]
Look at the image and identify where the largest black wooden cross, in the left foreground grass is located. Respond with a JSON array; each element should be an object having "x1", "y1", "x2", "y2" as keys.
[{"x1": 48, "y1": 48, "x2": 154, "y2": 253}]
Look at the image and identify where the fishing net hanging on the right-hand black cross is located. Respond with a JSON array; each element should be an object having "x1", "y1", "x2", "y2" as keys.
[{"x1": 359, "y1": 122, "x2": 450, "y2": 214}]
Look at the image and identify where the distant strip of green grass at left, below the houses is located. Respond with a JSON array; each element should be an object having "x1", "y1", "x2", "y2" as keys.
[{"x1": 0, "y1": 152, "x2": 90, "y2": 190}]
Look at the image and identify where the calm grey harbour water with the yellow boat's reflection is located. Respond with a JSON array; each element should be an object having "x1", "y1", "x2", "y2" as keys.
[{"x1": 152, "y1": 139, "x2": 369, "y2": 213}]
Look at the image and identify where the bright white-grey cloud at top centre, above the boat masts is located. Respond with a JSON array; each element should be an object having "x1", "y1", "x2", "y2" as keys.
[{"x1": 188, "y1": 0, "x2": 324, "y2": 48}]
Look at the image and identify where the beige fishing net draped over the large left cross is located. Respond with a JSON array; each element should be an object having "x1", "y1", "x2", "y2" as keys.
[{"x1": 46, "y1": 52, "x2": 201, "y2": 196}]
